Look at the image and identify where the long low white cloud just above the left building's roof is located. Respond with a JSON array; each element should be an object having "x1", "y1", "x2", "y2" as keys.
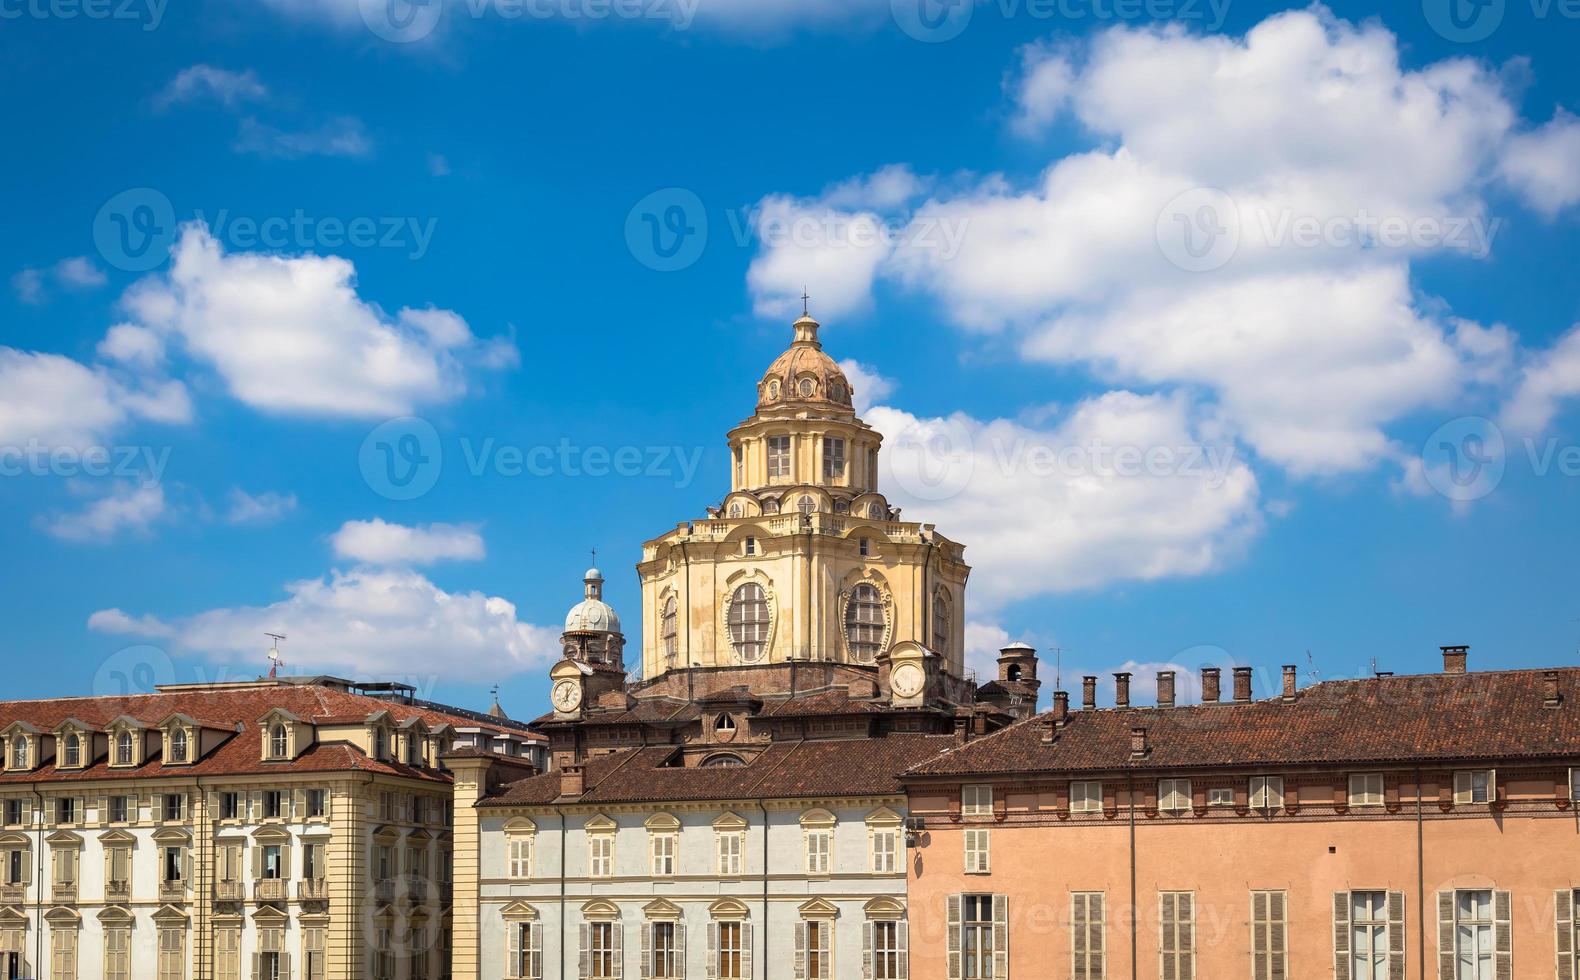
[{"x1": 88, "y1": 567, "x2": 559, "y2": 681}]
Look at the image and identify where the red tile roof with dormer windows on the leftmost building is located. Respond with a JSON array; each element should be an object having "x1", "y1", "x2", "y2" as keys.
[{"x1": 0, "y1": 684, "x2": 523, "y2": 787}]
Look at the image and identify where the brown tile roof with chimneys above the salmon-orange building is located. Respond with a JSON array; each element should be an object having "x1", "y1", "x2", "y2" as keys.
[{"x1": 907, "y1": 667, "x2": 1580, "y2": 776}]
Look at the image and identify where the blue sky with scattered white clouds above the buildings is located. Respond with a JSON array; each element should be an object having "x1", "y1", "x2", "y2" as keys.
[{"x1": 0, "y1": 0, "x2": 1580, "y2": 716}]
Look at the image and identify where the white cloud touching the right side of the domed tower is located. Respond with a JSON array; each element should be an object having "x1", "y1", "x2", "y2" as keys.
[{"x1": 866, "y1": 392, "x2": 1262, "y2": 612}]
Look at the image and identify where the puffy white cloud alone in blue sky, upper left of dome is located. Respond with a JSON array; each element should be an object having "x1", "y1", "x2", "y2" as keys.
[{"x1": 123, "y1": 223, "x2": 507, "y2": 417}]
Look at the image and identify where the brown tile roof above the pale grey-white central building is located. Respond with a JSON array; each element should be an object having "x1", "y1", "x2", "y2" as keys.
[{"x1": 480, "y1": 735, "x2": 953, "y2": 806}]
